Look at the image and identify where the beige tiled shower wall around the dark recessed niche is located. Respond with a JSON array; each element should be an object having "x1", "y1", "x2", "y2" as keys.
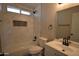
[{"x1": 2, "y1": 13, "x2": 33, "y2": 53}]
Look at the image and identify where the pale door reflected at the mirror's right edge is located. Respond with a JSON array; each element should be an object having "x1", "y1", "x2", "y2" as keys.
[{"x1": 71, "y1": 12, "x2": 79, "y2": 42}]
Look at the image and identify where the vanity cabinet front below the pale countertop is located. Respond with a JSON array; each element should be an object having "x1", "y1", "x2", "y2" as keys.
[{"x1": 45, "y1": 45, "x2": 66, "y2": 56}]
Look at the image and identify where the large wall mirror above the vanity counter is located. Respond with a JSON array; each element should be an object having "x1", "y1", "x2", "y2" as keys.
[{"x1": 56, "y1": 6, "x2": 79, "y2": 42}]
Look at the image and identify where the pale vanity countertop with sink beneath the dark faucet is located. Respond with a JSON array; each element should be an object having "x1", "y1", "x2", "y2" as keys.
[{"x1": 45, "y1": 40, "x2": 79, "y2": 56}]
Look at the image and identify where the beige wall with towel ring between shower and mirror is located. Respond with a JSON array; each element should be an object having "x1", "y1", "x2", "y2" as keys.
[{"x1": 40, "y1": 3, "x2": 56, "y2": 40}]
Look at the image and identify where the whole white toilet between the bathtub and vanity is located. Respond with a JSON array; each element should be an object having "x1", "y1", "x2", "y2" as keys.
[{"x1": 29, "y1": 37, "x2": 48, "y2": 56}]
